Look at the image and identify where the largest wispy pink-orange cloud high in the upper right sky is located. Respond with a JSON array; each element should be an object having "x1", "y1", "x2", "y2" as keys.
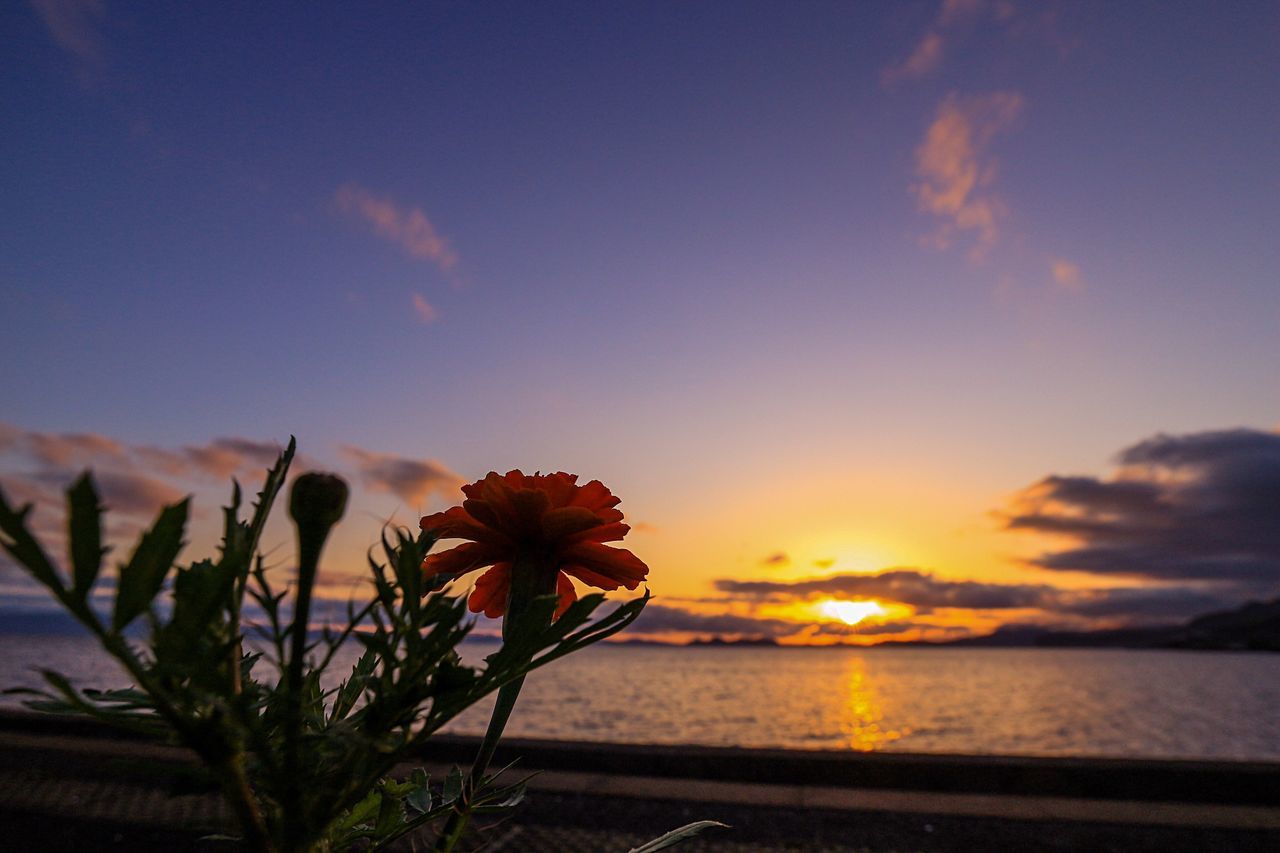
[{"x1": 911, "y1": 92, "x2": 1024, "y2": 259}]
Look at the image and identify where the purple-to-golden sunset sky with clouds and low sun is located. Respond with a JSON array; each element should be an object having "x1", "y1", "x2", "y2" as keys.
[{"x1": 0, "y1": 0, "x2": 1280, "y2": 643}]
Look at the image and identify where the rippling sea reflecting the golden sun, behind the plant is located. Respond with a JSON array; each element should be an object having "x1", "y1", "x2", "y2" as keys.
[{"x1": 0, "y1": 635, "x2": 1280, "y2": 761}]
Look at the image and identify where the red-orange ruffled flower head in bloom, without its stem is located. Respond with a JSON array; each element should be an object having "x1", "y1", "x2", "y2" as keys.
[{"x1": 420, "y1": 471, "x2": 649, "y2": 619}]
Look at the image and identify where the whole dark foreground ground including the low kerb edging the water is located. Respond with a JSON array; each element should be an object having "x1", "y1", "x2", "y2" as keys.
[{"x1": 0, "y1": 713, "x2": 1280, "y2": 853}]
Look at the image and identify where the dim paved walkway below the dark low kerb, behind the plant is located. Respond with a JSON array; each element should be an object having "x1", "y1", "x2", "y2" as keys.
[{"x1": 0, "y1": 729, "x2": 1280, "y2": 853}]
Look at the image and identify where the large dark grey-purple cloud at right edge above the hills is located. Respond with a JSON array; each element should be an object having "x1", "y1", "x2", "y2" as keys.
[{"x1": 998, "y1": 429, "x2": 1280, "y2": 597}]
